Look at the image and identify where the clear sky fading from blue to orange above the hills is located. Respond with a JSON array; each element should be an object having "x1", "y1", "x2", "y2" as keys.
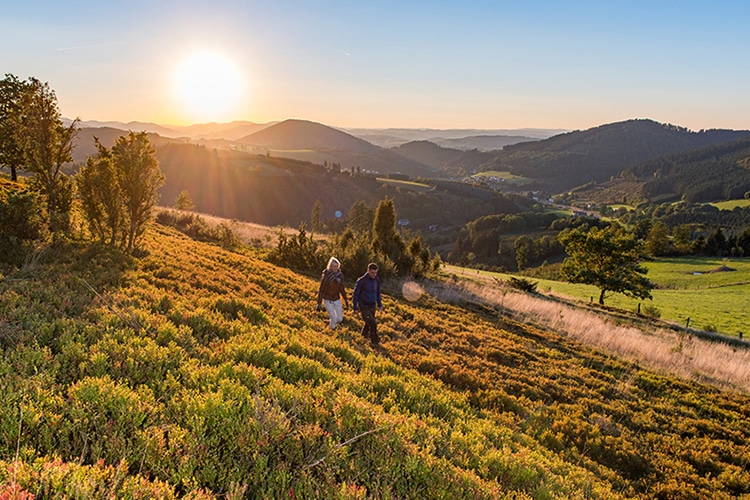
[{"x1": 0, "y1": 0, "x2": 750, "y2": 131}]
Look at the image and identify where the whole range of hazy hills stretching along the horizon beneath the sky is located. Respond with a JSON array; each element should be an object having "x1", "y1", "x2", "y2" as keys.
[{"x1": 64, "y1": 119, "x2": 750, "y2": 199}]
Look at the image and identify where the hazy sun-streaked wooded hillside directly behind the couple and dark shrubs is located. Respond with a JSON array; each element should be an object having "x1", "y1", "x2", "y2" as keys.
[{"x1": 156, "y1": 143, "x2": 529, "y2": 230}]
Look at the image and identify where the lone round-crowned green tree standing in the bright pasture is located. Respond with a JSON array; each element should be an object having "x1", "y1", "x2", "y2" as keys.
[{"x1": 559, "y1": 224, "x2": 654, "y2": 305}]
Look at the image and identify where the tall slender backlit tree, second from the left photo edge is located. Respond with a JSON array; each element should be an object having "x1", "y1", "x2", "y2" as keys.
[{"x1": 13, "y1": 78, "x2": 78, "y2": 233}]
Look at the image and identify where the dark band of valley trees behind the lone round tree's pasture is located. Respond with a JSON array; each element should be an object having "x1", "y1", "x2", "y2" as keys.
[{"x1": 446, "y1": 203, "x2": 750, "y2": 271}]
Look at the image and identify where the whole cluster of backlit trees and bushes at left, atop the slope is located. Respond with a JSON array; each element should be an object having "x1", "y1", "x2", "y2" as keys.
[{"x1": 0, "y1": 74, "x2": 164, "y2": 266}]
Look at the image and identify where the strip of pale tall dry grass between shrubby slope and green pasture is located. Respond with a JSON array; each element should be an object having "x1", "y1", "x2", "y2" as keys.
[{"x1": 426, "y1": 281, "x2": 750, "y2": 392}]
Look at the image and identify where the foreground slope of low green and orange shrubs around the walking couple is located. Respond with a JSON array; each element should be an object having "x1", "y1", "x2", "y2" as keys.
[{"x1": 0, "y1": 227, "x2": 750, "y2": 498}]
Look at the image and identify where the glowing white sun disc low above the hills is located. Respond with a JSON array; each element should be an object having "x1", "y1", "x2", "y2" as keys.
[{"x1": 174, "y1": 50, "x2": 244, "y2": 121}]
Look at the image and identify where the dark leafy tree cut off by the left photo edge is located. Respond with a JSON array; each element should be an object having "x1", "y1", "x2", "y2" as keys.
[{"x1": 0, "y1": 73, "x2": 28, "y2": 181}]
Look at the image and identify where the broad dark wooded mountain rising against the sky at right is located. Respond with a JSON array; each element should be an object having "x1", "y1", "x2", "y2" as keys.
[{"x1": 483, "y1": 120, "x2": 750, "y2": 192}]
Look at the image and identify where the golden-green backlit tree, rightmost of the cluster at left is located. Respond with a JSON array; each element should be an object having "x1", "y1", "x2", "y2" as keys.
[{"x1": 111, "y1": 131, "x2": 164, "y2": 250}]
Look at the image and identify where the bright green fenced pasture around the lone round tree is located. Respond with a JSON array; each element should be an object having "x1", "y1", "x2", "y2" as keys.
[{"x1": 446, "y1": 257, "x2": 750, "y2": 337}]
